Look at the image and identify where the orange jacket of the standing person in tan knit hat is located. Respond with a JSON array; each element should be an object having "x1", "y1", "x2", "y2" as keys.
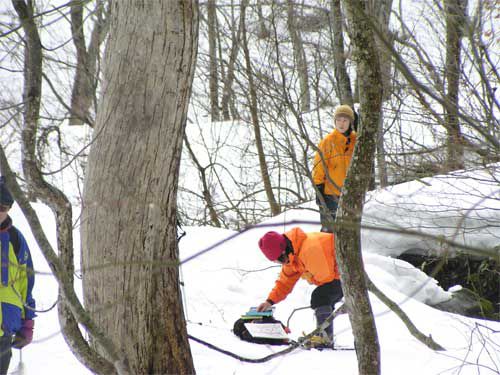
[{"x1": 312, "y1": 129, "x2": 356, "y2": 196}]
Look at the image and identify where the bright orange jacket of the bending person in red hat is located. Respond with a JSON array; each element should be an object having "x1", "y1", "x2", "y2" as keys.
[{"x1": 268, "y1": 227, "x2": 340, "y2": 303}]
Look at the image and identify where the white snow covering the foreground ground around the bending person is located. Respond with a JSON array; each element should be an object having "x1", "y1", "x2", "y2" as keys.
[{"x1": 4, "y1": 168, "x2": 500, "y2": 375}]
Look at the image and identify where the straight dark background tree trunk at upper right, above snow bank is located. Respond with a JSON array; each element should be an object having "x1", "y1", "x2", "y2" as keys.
[{"x1": 445, "y1": 0, "x2": 467, "y2": 171}]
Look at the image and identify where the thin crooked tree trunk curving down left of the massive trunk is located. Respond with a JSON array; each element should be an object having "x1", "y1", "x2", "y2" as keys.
[{"x1": 12, "y1": 0, "x2": 117, "y2": 373}]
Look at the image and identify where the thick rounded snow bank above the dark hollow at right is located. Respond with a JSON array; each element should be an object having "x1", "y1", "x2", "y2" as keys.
[{"x1": 363, "y1": 163, "x2": 500, "y2": 256}]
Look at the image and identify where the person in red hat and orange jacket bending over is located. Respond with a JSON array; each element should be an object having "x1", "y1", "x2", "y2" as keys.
[{"x1": 257, "y1": 227, "x2": 343, "y2": 346}]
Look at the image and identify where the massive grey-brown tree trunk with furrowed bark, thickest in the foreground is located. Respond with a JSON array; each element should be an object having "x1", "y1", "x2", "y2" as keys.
[{"x1": 82, "y1": 0, "x2": 198, "y2": 374}]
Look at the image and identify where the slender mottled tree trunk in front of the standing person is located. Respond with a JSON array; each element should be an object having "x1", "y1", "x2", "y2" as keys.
[{"x1": 335, "y1": 0, "x2": 383, "y2": 375}]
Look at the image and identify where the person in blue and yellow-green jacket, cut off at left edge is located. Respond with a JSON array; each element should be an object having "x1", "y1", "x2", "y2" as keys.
[{"x1": 0, "y1": 177, "x2": 35, "y2": 375}]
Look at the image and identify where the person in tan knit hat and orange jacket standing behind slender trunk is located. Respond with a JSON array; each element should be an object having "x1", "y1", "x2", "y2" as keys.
[{"x1": 312, "y1": 105, "x2": 356, "y2": 233}]
